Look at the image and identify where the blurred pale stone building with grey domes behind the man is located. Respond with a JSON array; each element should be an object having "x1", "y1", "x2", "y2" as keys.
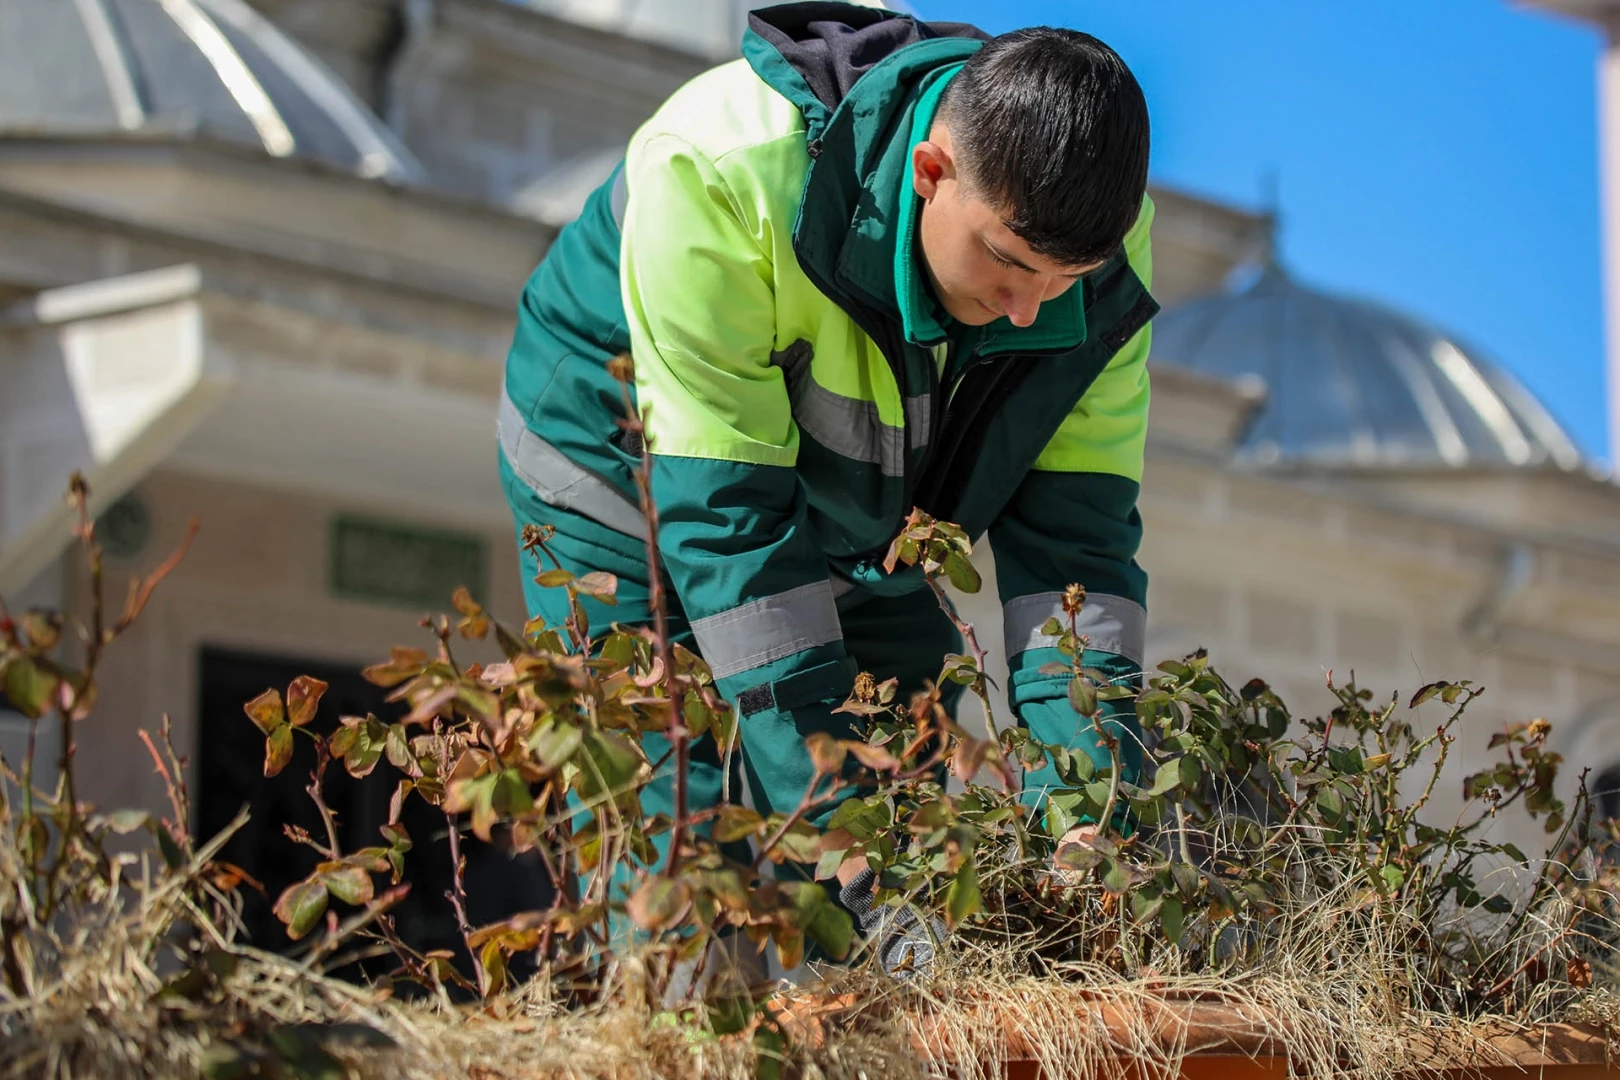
[{"x1": 0, "y1": 0, "x2": 1620, "y2": 932}]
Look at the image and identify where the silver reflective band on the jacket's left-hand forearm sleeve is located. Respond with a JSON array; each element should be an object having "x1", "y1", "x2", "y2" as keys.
[{"x1": 692, "y1": 581, "x2": 844, "y2": 678}]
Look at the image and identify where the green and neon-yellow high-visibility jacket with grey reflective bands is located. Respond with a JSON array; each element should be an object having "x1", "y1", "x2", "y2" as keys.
[{"x1": 501, "y1": 3, "x2": 1157, "y2": 799}]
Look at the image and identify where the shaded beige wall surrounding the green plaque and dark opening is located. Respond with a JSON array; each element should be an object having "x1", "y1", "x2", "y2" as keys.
[{"x1": 63, "y1": 463, "x2": 523, "y2": 810}]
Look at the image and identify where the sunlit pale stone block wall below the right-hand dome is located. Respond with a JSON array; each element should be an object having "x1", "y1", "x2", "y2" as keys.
[{"x1": 959, "y1": 455, "x2": 1620, "y2": 852}]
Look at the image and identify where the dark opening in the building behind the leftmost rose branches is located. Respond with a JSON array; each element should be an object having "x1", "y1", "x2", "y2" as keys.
[{"x1": 194, "y1": 648, "x2": 551, "y2": 978}]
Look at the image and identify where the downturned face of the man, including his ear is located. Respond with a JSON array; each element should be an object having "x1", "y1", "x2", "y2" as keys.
[{"x1": 912, "y1": 125, "x2": 1097, "y2": 327}]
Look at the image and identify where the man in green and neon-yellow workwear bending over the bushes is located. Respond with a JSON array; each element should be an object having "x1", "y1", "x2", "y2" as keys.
[{"x1": 501, "y1": 3, "x2": 1157, "y2": 965}]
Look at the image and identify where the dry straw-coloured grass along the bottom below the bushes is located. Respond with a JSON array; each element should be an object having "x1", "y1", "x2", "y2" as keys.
[{"x1": 0, "y1": 854, "x2": 1620, "y2": 1080}]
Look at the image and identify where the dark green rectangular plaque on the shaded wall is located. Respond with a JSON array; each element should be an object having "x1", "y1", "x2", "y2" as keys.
[{"x1": 332, "y1": 515, "x2": 489, "y2": 610}]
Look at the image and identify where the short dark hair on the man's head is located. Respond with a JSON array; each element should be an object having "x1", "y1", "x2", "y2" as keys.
[{"x1": 940, "y1": 26, "x2": 1149, "y2": 266}]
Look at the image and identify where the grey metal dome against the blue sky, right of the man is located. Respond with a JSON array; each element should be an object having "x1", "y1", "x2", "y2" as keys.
[{"x1": 1153, "y1": 266, "x2": 1583, "y2": 470}]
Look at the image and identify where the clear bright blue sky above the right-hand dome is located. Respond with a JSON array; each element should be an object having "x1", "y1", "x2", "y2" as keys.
[{"x1": 912, "y1": 0, "x2": 1609, "y2": 457}]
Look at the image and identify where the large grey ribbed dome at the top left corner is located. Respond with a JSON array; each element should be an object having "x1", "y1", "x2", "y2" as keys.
[{"x1": 0, "y1": 0, "x2": 421, "y2": 180}]
